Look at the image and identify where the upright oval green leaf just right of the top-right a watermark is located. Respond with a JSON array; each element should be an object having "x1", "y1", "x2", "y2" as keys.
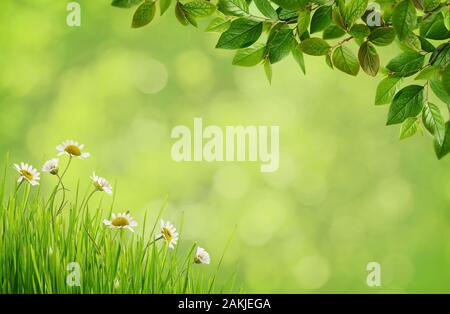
[{"x1": 392, "y1": 0, "x2": 417, "y2": 40}]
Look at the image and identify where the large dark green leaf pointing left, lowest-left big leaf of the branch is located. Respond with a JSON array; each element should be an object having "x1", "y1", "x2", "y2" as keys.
[{"x1": 216, "y1": 18, "x2": 262, "y2": 49}]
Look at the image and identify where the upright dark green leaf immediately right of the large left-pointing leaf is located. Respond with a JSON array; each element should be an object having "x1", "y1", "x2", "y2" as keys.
[{"x1": 267, "y1": 28, "x2": 295, "y2": 63}]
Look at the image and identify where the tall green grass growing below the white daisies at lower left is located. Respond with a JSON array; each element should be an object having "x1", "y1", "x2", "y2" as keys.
[{"x1": 0, "y1": 153, "x2": 234, "y2": 293}]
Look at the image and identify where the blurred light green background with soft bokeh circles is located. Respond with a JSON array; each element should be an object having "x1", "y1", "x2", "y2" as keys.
[{"x1": 0, "y1": 0, "x2": 450, "y2": 293}]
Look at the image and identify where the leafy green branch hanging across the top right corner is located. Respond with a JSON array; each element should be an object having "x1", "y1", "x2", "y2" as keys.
[{"x1": 112, "y1": 0, "x2": 450, "y2": 159}]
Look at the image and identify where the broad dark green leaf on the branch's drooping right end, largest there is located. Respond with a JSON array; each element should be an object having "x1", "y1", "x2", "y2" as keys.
[{"x1": 387, "y1": 85, "x2": 423, "y2": 125}]
